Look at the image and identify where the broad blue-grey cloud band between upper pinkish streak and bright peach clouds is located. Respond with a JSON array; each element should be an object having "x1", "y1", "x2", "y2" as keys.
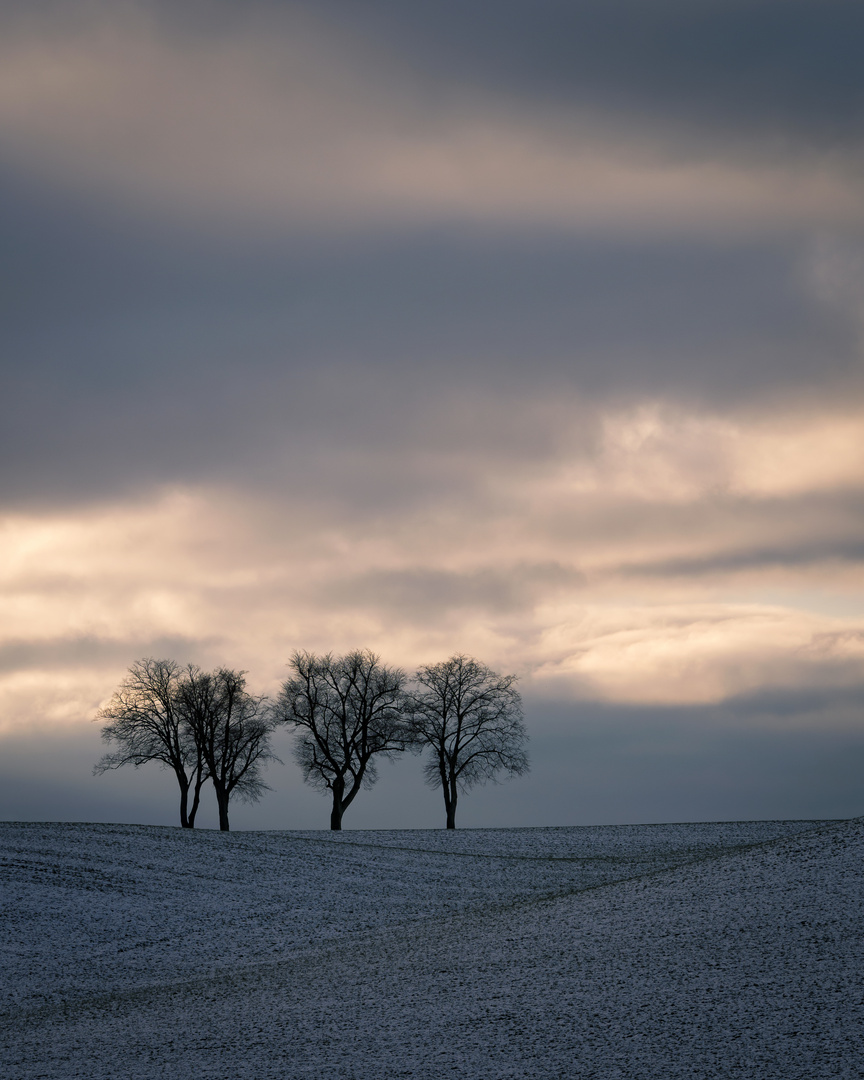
[{"x1": 0, "y1": 165, "x2": 860, "y2": 503}]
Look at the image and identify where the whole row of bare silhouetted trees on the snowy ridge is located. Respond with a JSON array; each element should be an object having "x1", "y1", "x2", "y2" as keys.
[{"x1": 95, "y1": 650, "x2": 528, "y2": 829}]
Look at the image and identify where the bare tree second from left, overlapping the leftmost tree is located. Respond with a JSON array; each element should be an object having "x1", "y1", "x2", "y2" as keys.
[{"x1": 177, "y1": 664, "x2": 279, "y2": 833}]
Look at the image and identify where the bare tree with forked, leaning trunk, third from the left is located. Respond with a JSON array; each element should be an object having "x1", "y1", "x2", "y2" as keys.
[{"x1": 276, "y1": 650, "x2": 408, "y2": 829}]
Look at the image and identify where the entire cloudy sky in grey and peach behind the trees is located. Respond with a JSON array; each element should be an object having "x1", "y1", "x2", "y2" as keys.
[{"x1": 0, "y1": 0, "x2": 864, "y2": 828}]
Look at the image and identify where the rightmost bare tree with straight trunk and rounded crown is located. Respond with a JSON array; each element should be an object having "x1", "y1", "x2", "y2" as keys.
[{"x1": 411, "y1": 654, "x2": 528, "y2": 828}]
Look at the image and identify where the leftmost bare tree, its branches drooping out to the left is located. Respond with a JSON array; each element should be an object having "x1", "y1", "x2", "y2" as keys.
[{"x1": 93, "y1": 657, "x2": 207, "y2": 828}]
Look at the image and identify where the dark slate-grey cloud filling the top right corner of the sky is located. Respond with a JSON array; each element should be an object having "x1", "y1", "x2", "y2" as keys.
[{"x1": 306, "y1": 0, "x2": 864, "y2": 153}]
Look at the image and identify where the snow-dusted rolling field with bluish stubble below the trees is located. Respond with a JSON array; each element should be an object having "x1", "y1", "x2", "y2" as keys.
[{"x1": 0, "y1": 819, "x2": 864, "y2": 1080}]
